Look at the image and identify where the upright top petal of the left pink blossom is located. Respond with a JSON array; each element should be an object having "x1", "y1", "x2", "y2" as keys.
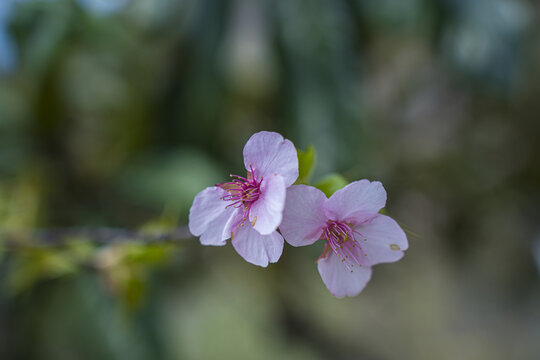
[{"x1": 244, "y1": 131, "x2": 298, "y2": 187}]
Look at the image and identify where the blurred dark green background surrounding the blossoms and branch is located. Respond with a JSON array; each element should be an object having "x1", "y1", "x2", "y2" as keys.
[{"x1": 0, "y1": 0, "x2": 540, "y2": 360}]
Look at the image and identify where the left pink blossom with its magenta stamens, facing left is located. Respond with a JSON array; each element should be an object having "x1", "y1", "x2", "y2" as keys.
[{"x1": 189, "y1": 131, "x2": 298, "y2": 267}]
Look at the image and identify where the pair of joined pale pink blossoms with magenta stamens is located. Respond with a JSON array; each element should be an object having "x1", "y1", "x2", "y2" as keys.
[{"x1": 189, "y1": 131, "x2": 408, "y2": 298}]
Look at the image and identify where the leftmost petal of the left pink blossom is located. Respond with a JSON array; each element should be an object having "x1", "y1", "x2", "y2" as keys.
[{"x1": 189, "y1": 186, "x2": 227, "y2": 236}]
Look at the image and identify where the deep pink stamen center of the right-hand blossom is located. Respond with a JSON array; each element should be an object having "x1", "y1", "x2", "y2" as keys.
[{"x1": 323, "y1": 220, "x2": 366, "y2": 271}]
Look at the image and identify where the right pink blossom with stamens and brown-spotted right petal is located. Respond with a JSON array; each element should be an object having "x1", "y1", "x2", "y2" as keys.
[{"x1": 279, "y1": 180, "x2": 408, "y2": 298}]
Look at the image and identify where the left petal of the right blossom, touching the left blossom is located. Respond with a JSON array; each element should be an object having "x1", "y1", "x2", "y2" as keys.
[{"x1": 279, "y1": 185, "x2": 327, "y2": 246}]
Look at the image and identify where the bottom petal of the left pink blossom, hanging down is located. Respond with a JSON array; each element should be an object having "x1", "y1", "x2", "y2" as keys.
[{"x1": 232, "y1": 222, "x2": 283, "y2": 267}]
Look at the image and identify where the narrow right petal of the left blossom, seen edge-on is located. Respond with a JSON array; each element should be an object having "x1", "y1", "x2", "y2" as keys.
[{"x1": 249, "y1": 175, "x2": 286, "y2": 235}]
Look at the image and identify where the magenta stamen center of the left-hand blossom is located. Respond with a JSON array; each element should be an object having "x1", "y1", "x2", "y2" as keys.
[{"x1": 216, "y1": 166, "x2": 263, "y2": 223}]
